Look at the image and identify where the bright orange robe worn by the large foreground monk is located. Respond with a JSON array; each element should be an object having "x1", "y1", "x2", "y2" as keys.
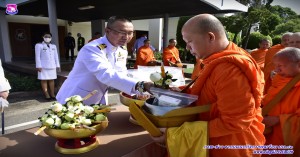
[{"x1": 168, "y1": 42, "x2": 265, "y2": 157}]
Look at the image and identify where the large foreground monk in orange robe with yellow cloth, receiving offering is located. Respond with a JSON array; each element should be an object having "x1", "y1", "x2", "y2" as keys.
[{"x1": 152, "y1": 14, "x2": 265, "y2": 157}]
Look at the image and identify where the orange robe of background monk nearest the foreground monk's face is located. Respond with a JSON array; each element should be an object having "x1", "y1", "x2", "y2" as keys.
[{"x1": 162, "y1": 45, "x2": 181, "y2": 66}]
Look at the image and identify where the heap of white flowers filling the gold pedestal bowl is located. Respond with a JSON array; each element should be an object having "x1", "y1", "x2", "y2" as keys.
[{"x1": 38, "y1": 95, "x2": 110, "y2": 129}]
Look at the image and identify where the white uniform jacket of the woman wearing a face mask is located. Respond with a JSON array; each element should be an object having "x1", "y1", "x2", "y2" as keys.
[{"x1": 35, "y1": 42, "x2": 60, "y2": 69}]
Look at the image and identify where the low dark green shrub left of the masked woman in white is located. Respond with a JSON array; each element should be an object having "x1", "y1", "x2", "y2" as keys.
[{"x1": 5, "y1": 71, "x2": 41, "y2": 92}]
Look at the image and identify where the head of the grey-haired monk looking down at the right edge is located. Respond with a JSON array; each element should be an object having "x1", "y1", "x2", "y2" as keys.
[{"x1": 273, "y1": 47, "x2": 300, "y2": 77}]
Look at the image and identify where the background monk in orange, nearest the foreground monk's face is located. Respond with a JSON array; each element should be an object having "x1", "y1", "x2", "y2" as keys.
[{"x1": 162, "y1": 39, "x2": 182, "y2": 67}]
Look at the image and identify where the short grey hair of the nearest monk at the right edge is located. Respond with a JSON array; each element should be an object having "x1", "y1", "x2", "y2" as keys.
[{"x1": 274, "y1": 47, "x2": 300, "y2": 62}]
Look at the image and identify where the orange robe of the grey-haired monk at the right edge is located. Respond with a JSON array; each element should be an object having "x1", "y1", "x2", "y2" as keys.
[{"x1": 262, "y1": 75, "x2": 300, "y2": 156}]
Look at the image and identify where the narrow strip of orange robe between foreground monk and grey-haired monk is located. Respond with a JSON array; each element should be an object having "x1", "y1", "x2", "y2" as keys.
[{"x1": 264, "y1": 44, "x2": 284, "y2": 94}]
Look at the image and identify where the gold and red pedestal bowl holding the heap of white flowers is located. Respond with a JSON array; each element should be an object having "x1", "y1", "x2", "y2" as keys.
[{"x1": 44, "y1": 120, "x2": 108, "y2": 154}]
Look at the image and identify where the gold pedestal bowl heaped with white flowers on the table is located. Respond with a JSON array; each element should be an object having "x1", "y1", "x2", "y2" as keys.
[{"x1": 35, "y1": 95, "x2": 110, "y2": 154}]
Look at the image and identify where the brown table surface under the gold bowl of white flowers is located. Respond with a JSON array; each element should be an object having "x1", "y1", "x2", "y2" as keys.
[{"x1": 0, "y1": 104, "x2": 152, "y2": 157}]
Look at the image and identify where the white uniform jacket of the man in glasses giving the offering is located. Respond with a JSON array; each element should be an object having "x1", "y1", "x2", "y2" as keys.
[{"x1": 56, "y1": 36, "x2": 137, "y2": 105}]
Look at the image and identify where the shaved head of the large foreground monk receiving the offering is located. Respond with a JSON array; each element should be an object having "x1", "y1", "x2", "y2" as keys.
[{"x1": 181, "y1": 14, "x2": 229, "y2": 59}]
